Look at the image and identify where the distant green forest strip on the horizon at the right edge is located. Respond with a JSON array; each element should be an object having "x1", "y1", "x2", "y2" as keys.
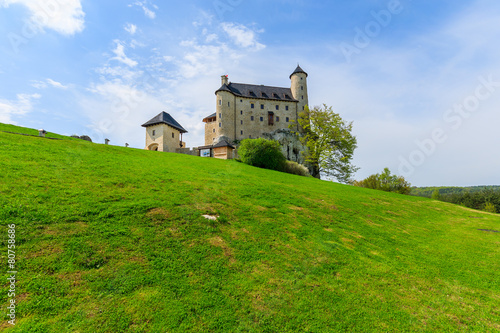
[{"x1": 410, "y1": 186, "x2": 500, "y2": 213}]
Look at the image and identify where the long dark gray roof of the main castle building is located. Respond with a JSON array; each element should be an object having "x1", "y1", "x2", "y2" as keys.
[{"x1": 215, "y1": 82, "x2": 298, "y2": 102}]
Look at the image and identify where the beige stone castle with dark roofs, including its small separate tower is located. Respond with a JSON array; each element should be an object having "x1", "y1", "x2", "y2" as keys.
[{"x1": 142, "y1": 66, "x2": 309, "y2": 163}]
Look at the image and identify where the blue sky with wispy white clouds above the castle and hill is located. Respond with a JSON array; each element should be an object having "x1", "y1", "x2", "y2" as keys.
[{"x1": 0, "y1": 0, "x2": 500, "y2": 186}]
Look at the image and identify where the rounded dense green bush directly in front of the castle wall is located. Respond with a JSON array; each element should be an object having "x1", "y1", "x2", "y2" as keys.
[{"x1": 238, "y1": 138, "x2": 286, "y2": 171}]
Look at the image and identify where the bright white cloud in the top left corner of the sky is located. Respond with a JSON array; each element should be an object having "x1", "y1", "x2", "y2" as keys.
[{"x1": 0, "y1": 0, "x2": 85, "y2": 35}]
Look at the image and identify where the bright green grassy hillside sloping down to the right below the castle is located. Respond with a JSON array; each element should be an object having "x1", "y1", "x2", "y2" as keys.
[{"x1": 0, "y1": 125, "x2": 500, "y2": 332}]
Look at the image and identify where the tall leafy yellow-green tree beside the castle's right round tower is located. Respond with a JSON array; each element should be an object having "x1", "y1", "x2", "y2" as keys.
[{"x1": 290, "y1": 104, "x2": 359, "y2": 183}]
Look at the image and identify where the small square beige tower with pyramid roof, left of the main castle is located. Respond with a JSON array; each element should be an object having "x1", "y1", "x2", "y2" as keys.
[{"x1": 142, "y1": 112, "x2": 187, "y2": 153}]
